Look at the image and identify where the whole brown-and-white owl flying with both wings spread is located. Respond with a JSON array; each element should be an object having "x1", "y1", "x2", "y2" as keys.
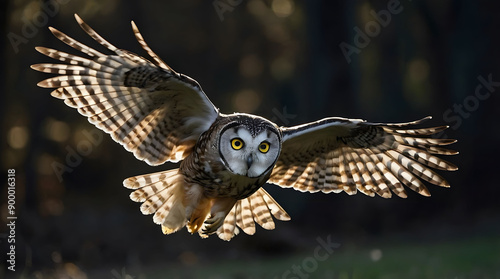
[{"x1": 31, "y1": 14, "x2": 457, "y2": 240}]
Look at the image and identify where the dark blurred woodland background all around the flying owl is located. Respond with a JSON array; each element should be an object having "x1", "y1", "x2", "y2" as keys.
[{"x1": 0, "y1": 0, "x2": 500, "y2": 278}]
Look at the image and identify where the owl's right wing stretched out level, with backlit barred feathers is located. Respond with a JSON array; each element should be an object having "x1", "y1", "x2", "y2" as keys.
[{"x1": 269, "y1": 117, "x2": 457, "y2": 198}]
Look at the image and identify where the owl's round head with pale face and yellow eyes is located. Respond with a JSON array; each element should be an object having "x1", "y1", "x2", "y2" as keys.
[{"x1": 219, "y1": 114, "x2": 281, "y2": 177}]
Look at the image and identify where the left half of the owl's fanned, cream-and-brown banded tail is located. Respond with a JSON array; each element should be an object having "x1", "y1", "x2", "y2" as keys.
[{"x1": 123, "y1": 169, "x2": 187, "y2": 234}]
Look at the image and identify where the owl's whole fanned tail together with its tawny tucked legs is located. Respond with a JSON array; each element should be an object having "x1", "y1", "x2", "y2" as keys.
[{"x1": 123, "y1": 169, "x2": 290, "y2": 241}]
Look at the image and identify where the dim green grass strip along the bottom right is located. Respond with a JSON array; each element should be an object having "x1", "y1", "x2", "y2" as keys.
[{"x1": 140, "y1": 237, "x2": 500, "y2": 279}]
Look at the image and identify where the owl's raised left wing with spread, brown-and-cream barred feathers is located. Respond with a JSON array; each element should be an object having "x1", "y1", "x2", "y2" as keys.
[{"x1": 31, "y1": 14, "x2": 219, "y2": 165}]
